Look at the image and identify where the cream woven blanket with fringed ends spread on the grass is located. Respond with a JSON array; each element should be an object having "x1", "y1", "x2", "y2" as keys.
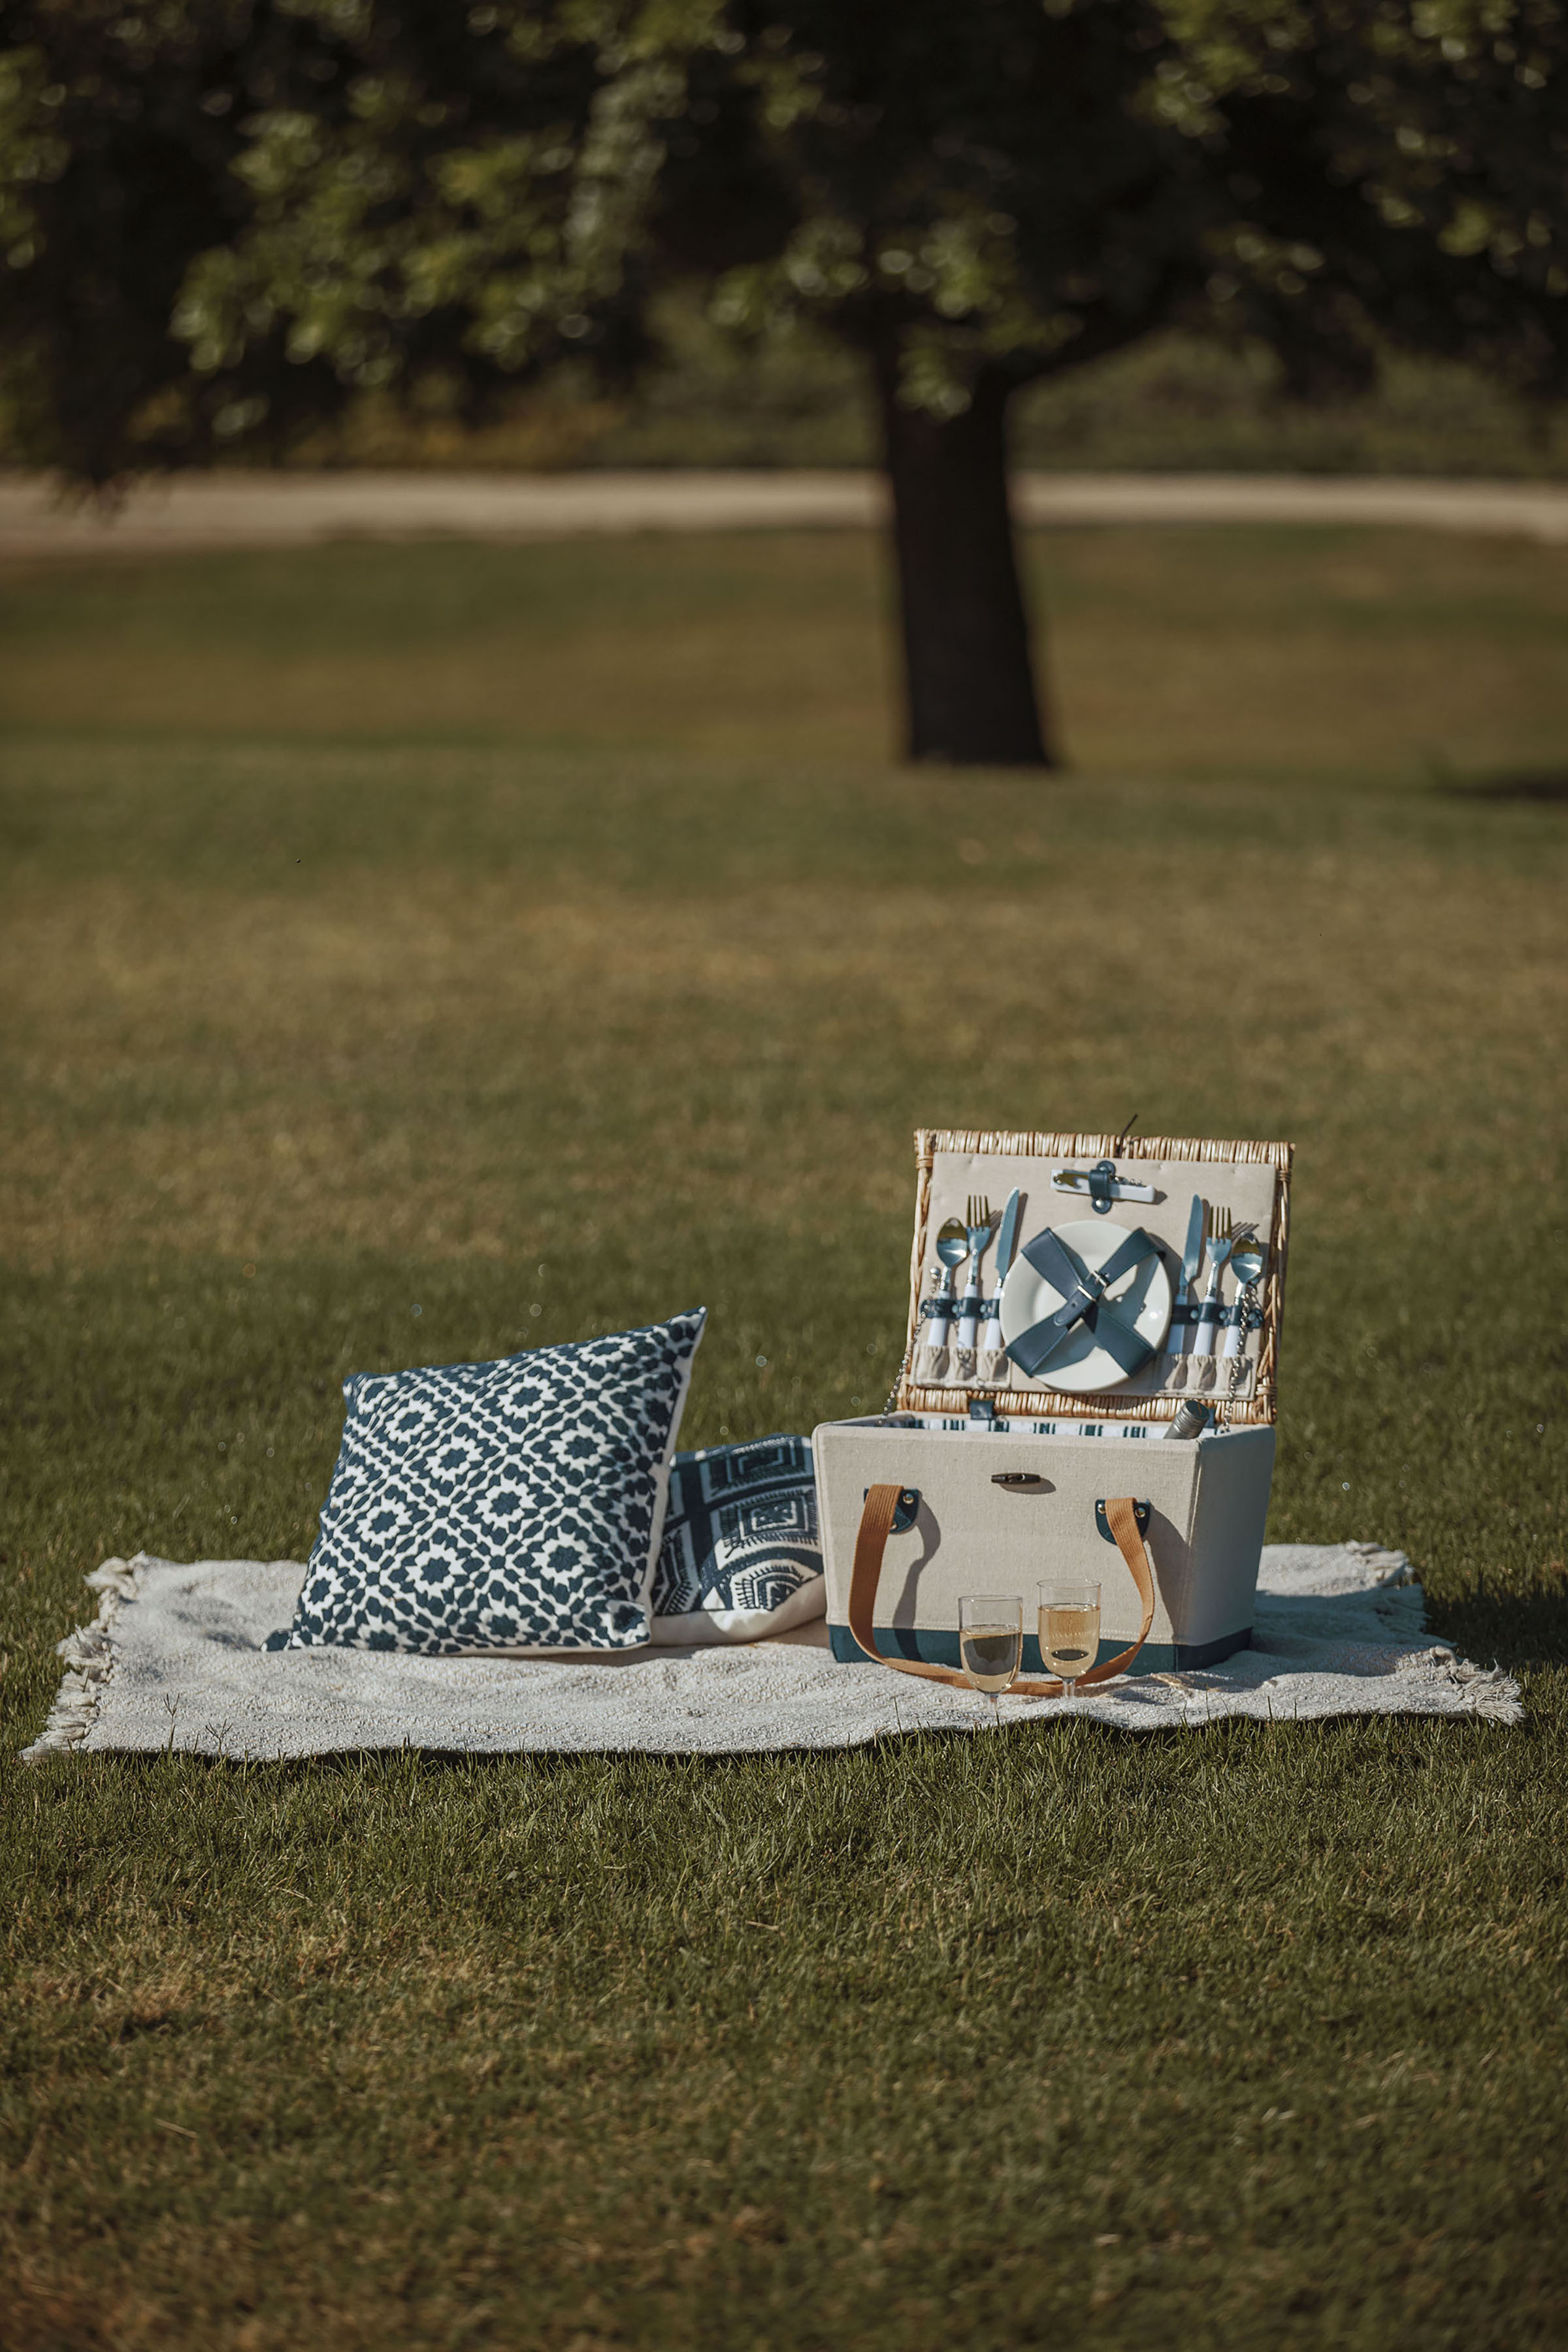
[{"x1": 26, "y1": 1543, "x2": 1524, "y2": 1759}]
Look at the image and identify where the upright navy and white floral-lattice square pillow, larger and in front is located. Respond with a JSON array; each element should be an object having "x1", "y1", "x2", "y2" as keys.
[{"x1": 268, "y1": 1308, "x2": 705, "y2": 1658}]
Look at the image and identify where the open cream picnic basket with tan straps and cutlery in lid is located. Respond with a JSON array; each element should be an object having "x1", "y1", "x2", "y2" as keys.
[{"x1": 813, "y1": 1129, "x2": 1290, "y2": 1693}]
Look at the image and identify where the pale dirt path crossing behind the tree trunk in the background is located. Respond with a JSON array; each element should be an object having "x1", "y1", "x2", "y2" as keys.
[{"x1": 0, "y1": 473, "x2": 1568, "y2": 555}]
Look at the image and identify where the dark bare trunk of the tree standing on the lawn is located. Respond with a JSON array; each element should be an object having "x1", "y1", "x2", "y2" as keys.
[{"x1": 877, "y1": 348, "x2": 1056, "y2": 767}]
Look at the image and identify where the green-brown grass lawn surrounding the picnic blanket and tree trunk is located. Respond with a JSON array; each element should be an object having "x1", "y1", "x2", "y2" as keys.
[{"x1": 0, "y1": 532, "x2": 1568, "y2": 2352}]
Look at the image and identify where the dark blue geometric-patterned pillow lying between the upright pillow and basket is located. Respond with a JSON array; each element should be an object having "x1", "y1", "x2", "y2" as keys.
[{"x1": 653, "y1": 1437, "x2": 828, "y2": 1642}]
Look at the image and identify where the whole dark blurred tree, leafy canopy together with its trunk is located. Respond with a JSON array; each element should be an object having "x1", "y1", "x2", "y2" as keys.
[{"x1": 0, "y1": 0, "x2": 1568, "y2": 762}]
